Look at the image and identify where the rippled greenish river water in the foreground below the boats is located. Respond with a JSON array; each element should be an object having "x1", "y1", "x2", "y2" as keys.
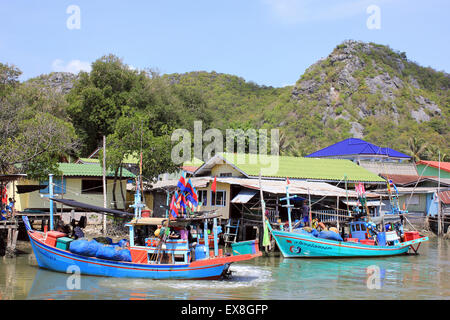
[{"x1": 0, "y1": 239, "x2": 450, "y2": 300}]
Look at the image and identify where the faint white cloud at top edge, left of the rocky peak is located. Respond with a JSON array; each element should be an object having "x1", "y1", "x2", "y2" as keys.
[{"x1": 264, "y1": 0, "x2": 388, "y2": 23}]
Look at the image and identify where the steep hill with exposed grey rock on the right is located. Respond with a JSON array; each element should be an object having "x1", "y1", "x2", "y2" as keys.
[{"x1": 287, "y1": 41, "x2": 450, "y2": 156}]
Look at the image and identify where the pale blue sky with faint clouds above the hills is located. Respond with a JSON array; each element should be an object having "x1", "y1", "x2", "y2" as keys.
[{"x1": 0, "y1": 0, "x2": 450, "y2": 87}]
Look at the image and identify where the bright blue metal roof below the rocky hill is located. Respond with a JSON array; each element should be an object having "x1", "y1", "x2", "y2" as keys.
[{"x1": 306, "y1": 138, "x2": 411, "y2": 158}]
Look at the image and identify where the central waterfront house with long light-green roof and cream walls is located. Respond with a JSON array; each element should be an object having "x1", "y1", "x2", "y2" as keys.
[{"x1": 144, "y1": 153, "x2": 386, "y2": 239}]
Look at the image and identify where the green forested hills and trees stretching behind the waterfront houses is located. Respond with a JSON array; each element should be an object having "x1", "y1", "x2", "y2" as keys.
[{"x1": 5, "y1": 41, "x2": 450, "y2": 180}]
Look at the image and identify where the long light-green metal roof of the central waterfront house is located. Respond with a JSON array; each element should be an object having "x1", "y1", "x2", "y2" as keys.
[{"x1": 219, "y1": 153, "x2": 386, "y2": 182}]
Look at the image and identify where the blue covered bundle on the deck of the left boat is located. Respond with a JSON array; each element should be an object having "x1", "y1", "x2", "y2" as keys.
[{"x1": 69, "y1": 239, "x2": 131, "y2": 262}]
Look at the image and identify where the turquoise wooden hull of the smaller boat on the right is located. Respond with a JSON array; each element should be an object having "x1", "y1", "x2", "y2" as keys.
[{"x1": 272, "y1": 230, "x2": 428, "y2": 258}]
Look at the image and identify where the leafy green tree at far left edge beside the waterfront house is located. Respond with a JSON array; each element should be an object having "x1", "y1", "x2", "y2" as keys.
[{"x1": 0, "y1": 65, "x2": 76, "y2": 179}]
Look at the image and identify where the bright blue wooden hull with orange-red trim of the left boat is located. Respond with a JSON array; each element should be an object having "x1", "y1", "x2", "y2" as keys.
[{"x1": 28, "y1": 230, "x2": 261, "y2": 279}]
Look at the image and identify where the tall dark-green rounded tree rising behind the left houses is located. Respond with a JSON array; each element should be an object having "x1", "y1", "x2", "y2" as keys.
[{"x1": 67, "y1": 55, "x2": 146, "y2": 153}]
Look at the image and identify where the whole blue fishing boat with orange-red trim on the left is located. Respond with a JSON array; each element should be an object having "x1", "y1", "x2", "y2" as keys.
[{"x1": 23, "y1": 176, "x2": 261, "y2": 279}]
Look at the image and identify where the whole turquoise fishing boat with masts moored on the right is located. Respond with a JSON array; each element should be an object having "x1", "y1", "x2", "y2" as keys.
[{"x1": 266, "y1": 181, "x2": 428, "y2": 258}]
